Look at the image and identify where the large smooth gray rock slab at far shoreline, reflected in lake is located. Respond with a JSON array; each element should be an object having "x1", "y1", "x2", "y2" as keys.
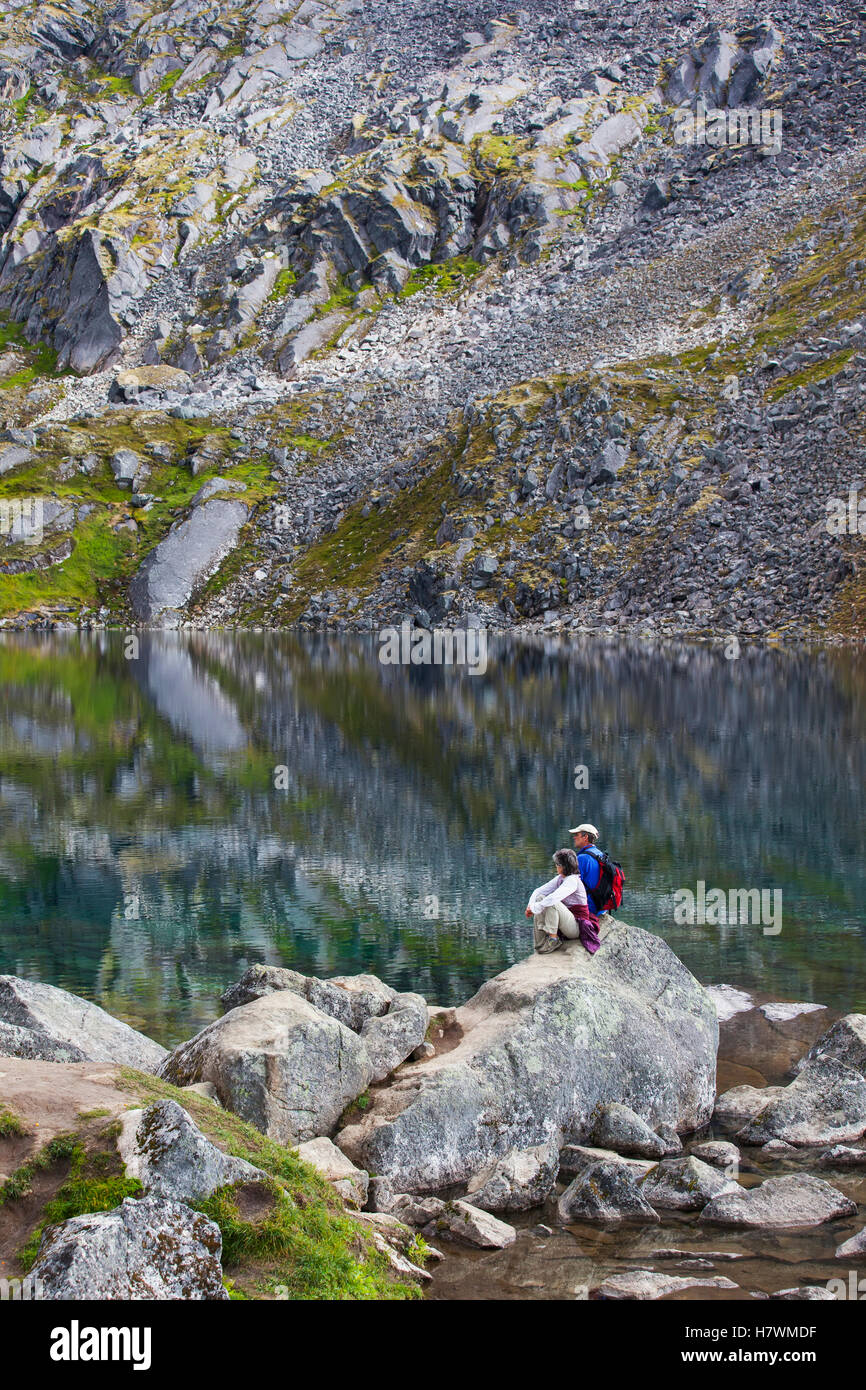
[{"x1": 129, "y1": 498, "x2": 249, "y2": 623}]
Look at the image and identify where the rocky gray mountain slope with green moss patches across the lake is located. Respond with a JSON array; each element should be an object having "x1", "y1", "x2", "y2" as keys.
[{"x1": 0, "y1": 0, "x2": 866, "y2": 635}]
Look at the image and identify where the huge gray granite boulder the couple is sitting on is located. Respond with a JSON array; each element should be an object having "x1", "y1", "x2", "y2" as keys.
[{"x1": 336, "y1": 923, "x2": 719, "y2": 1193}]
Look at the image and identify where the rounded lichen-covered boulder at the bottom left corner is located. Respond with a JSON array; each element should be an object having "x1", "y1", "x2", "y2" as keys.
[{"x1": 31, "y1": 1197, "x2": 228, "y2": 1301}]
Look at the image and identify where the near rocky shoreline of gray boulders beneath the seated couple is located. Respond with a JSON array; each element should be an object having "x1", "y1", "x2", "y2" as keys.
[{"x1": 0, "y1": 922, "x2": 866, "y2": 1300}]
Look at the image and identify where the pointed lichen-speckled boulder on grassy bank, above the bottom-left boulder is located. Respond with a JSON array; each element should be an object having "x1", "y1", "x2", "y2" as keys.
[{"x1": 117, "y1": 1101, "x2": 265, "y2": 1202}]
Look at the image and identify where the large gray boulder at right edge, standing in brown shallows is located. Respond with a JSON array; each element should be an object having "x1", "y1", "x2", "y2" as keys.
[{"x1": 737, "y1": 1056, "x2": 866, "y2": 1145}]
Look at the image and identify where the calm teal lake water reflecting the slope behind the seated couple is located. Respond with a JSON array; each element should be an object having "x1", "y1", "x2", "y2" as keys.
[{"x1": 0, "y1": 632, "x2": 866, "y2": 1045}]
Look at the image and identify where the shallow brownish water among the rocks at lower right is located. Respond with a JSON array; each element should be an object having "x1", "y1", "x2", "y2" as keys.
[{"x1": 430, "y1": 995, "x2": 866, "y2": 1307}]
